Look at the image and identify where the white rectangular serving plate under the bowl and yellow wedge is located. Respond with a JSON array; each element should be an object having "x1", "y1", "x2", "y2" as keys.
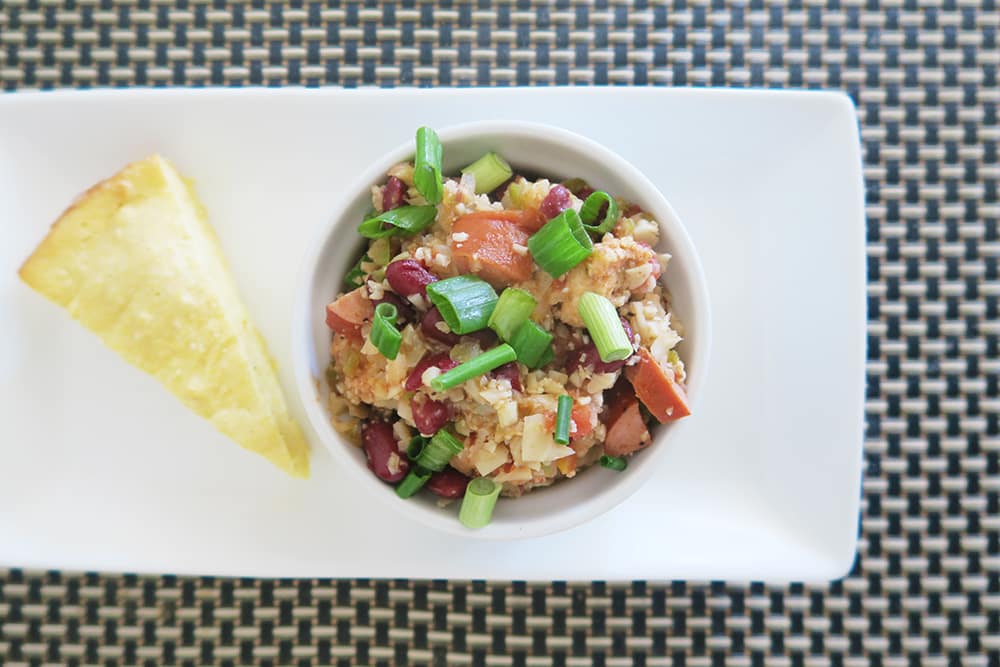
[{"x1": 0, "y1": 88, "x2": 865, "y2": 581}]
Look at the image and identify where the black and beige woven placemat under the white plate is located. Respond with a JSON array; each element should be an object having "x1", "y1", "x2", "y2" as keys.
[{"x1": 0, "y1": 0, "x2": 1000, "y2": 667}]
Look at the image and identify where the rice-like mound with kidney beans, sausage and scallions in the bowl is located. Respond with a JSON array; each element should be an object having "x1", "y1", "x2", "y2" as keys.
[{"x1": 326, "y1": 128, "x2": 690, "y2": 528}]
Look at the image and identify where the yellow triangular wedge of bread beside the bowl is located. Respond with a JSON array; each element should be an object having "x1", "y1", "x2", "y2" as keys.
[{"x1": 20, "y1": 155, "x2": 309, "y2": 477}]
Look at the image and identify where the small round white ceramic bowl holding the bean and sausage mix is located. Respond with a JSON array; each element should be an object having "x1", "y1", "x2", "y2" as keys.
[{"x1": 292, "y1": 121, "x2": 711, "y2": 540}]
